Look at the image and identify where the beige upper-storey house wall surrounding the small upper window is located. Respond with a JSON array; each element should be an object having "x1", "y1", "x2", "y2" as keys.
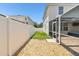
[{"x1": 48, "y1": 3, "x2": 77, "y2": 20}]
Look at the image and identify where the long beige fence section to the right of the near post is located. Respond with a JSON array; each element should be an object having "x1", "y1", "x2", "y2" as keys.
[{"x1": 9, "y1": 17, "x2": 35, "y2": 55}]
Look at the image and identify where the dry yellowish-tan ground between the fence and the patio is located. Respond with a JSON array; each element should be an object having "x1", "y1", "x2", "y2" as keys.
[{"x1": 18, "y1": 39, "x2": 72, "y2": 56}]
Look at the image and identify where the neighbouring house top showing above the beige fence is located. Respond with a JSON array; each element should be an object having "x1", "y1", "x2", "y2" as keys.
[{"x1": 0, "y1": 14, "x2": 34, "y2": 25}]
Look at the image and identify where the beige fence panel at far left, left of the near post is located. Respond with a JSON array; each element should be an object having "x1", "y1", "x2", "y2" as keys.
[{"x1": 0, "y1": 16, "x2": 8, "y2": 56}]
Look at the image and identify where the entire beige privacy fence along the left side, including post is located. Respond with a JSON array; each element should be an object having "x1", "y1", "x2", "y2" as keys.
[{"x1": 0, "y1": 15, "x2": 35, "y2": 55}]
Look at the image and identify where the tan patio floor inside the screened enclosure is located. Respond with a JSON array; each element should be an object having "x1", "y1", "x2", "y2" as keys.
[{"x1": 61, "y1": 36, "x2": 79, "y2": 56}]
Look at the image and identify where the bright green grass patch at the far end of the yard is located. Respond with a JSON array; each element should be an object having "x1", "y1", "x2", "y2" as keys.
[{"x1": 32, "y1": 32, "x2": 50, "y2": 39}]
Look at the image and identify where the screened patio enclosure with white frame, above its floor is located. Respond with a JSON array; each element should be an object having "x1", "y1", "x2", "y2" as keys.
[{"x1": 49, "y1": 6, "x2": 79, "y2": 44}]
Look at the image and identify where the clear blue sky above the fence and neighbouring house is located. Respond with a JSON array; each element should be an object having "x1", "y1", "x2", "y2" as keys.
[{"x1": 0, "y1": 3, "x2": 47, "y2": 23}]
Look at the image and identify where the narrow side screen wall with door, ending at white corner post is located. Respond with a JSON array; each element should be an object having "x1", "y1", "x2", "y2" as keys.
[{"x1": 51, "y1": 17, "x2": 61, "y2": 44}]
